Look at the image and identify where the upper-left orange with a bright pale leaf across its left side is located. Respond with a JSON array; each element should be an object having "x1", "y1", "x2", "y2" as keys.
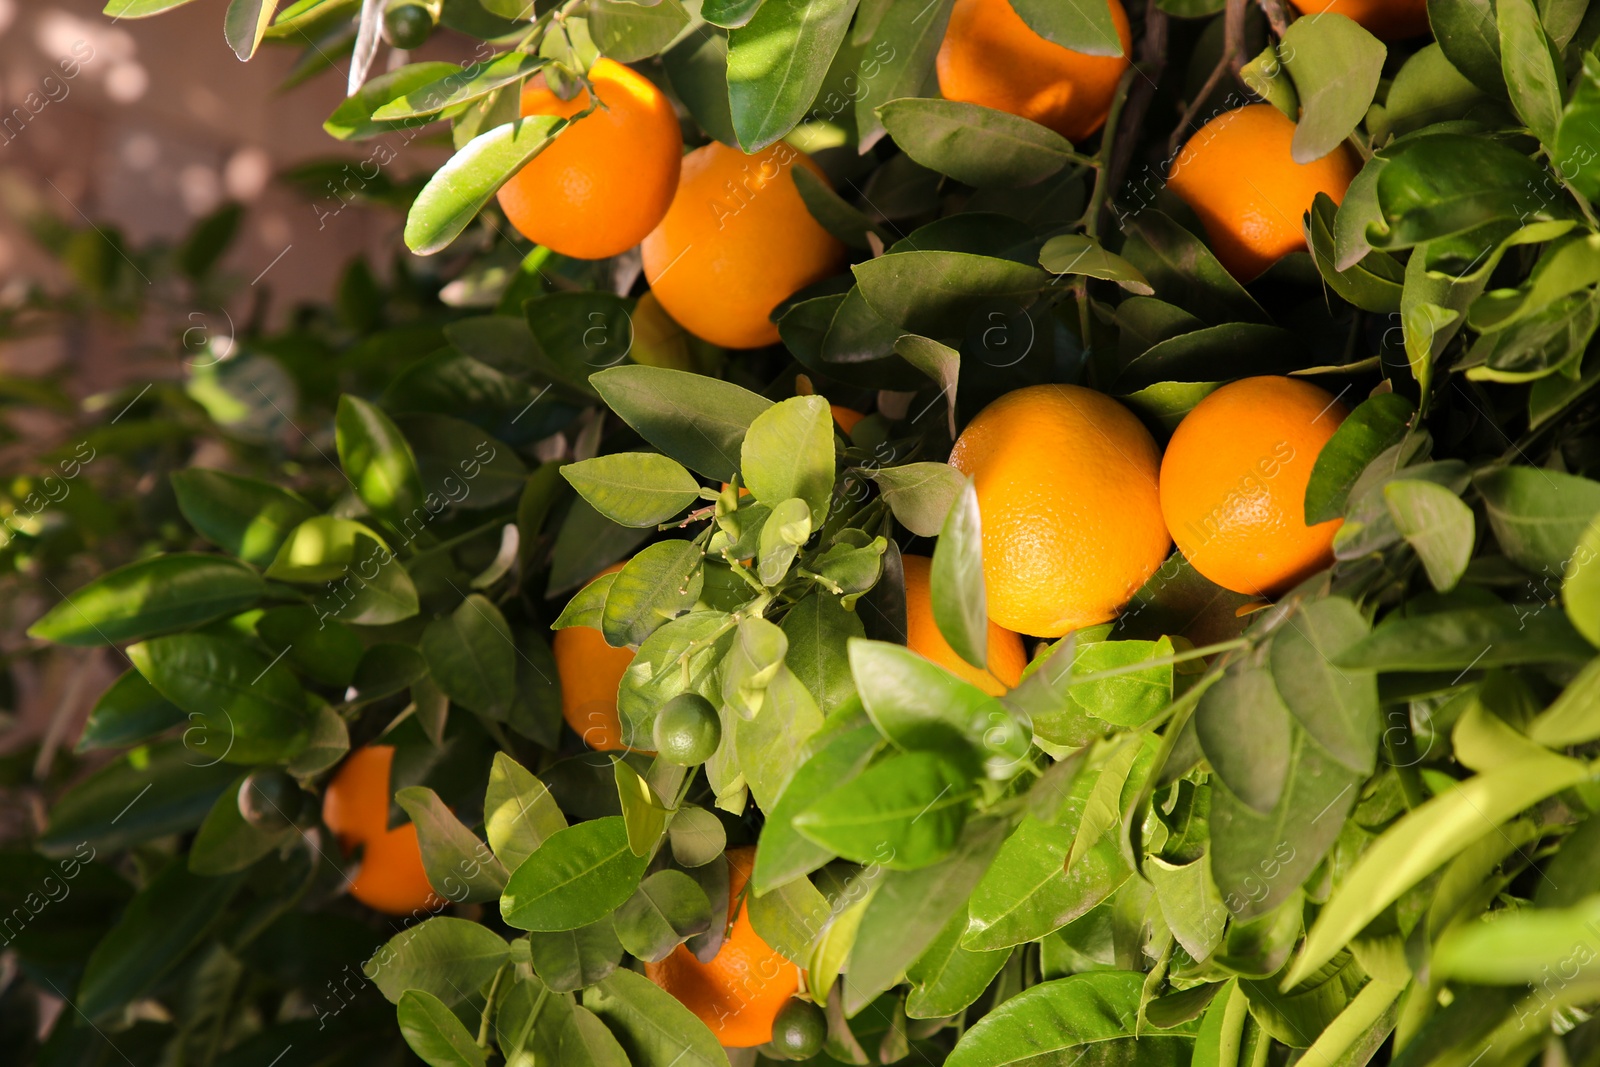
[{"x1": 499, "y1": 59, "x2": 683, "y2": 259}]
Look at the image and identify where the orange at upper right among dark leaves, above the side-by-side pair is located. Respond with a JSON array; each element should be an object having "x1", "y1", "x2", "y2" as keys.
[{"x1": 1171, "y1": 104, "x2": 1362, "y2": 282}]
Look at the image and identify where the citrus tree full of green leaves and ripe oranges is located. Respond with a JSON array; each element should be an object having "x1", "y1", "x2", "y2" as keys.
[{"x1": 15, "y1": 0, "x2": 1600, "y2": 1067}]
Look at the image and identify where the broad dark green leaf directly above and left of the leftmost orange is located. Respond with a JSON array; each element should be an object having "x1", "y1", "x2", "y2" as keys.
[{"x1": 128, "y1": 633, "x2": 312, "y2": 763}]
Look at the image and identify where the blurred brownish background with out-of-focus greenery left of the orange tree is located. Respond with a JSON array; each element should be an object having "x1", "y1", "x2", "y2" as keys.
[{"x1": 0, "y1": 0, "x2": 467, "y2": 841}]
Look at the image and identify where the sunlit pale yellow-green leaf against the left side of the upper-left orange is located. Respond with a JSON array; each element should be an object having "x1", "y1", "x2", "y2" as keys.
[{"x1": 405, "y1": 115, "x2": 566, "y2": 256}]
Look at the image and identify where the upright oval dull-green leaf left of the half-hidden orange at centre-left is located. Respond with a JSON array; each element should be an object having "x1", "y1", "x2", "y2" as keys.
[{"x1": 419, "y1": 593, "x2": 517, "y2": 720}]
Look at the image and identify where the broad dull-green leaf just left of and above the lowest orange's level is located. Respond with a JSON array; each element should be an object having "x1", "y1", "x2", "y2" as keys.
[{"x1": 362, "y1": 915, "x2": 510, "y2": 1006}]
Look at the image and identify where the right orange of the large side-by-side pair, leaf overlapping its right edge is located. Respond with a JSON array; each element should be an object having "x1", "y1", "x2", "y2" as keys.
[{"x1": 1162, "y1": 378, "x2": 1346, "y2": 597}]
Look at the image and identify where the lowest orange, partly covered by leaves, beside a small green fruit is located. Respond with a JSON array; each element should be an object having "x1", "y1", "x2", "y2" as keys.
[{"x1": 645, "y1": 848, "x2": 800, "y2": 1048}]
